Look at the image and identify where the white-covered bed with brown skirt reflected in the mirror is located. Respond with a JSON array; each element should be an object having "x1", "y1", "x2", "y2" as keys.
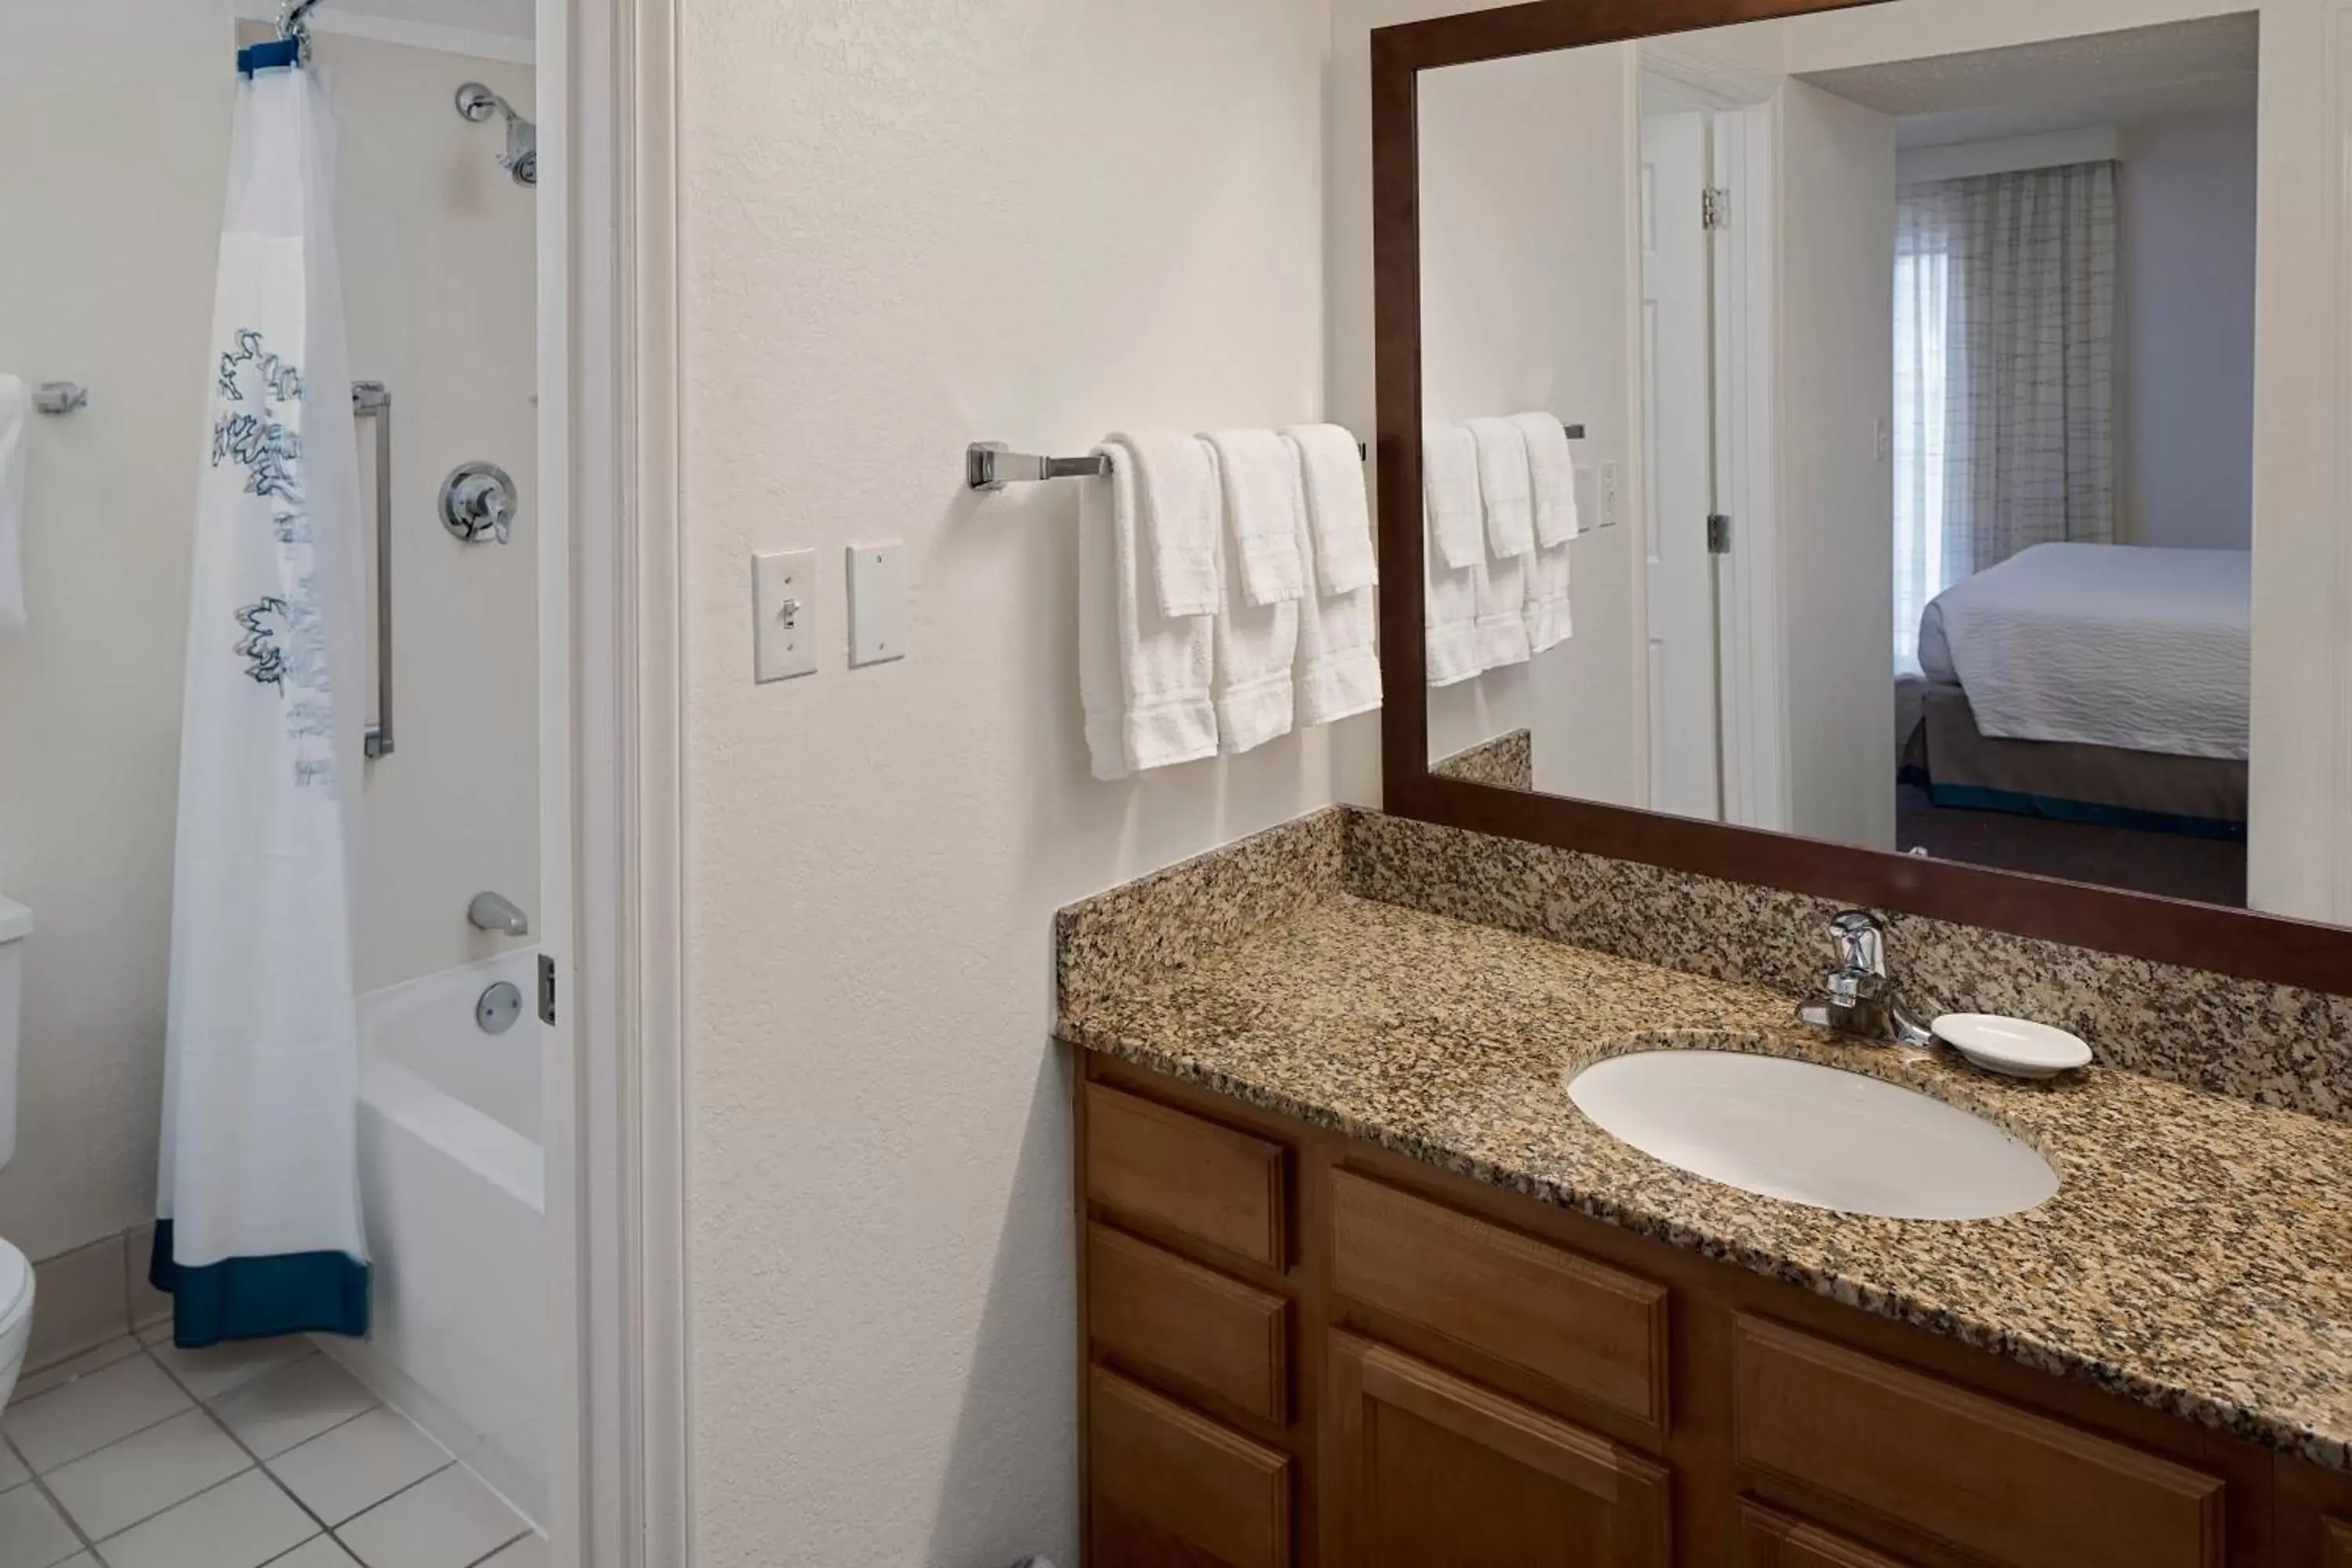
[{"x1": 1896, "y1": 543, "x2": 2253, "y2": 905}]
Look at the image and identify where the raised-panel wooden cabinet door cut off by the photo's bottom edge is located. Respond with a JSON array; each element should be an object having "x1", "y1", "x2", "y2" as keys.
[{"x1": 1327, "y1": 1333, "x2": 1672, "y2": 1568}]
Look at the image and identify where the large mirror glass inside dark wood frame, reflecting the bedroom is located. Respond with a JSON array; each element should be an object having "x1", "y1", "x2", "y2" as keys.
[{"x1": 1418, "y1": 0, "x2": 2305, "y2": 912}]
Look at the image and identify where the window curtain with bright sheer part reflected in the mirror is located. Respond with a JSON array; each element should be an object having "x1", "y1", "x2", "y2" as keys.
[{"x1": 1893, "y1": 162, "x2": 2117, "y2": 670}]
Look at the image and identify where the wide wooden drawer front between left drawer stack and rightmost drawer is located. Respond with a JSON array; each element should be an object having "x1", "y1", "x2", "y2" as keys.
[{"x1": 1331, "y1": 1171, "x2": 1668, "y2": 1434}]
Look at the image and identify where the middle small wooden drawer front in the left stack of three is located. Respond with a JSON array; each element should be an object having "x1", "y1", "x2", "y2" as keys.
[{"x1": 1087, "y1": 1225, "x2": 1291, "y2": 1425}]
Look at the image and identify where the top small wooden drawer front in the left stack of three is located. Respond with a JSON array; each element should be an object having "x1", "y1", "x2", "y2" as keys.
[{"x1": 1087, "y1": 1083, "x2": 1289, "y2": 1269}]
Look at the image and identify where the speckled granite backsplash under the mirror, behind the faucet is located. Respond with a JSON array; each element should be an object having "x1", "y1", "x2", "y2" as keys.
[{"x1": 1348, "y1": 811, "x2": 2352, "y2": 1119}]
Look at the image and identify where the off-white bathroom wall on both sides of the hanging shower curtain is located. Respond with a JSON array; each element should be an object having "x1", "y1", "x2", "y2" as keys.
[{"x1": 0, "y1": 0, "x2": 539, "y2": 1258}]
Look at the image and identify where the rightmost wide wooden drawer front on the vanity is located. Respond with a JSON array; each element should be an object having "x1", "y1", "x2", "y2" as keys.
[{"x1": 1733, "y1": 1316, "x2": 2225, "y2": 1568}]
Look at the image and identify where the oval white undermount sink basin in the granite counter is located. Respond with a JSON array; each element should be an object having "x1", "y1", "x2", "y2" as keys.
[{"x1": 1569, "y1": 1051, "x2": 2058, "y2": 1220}]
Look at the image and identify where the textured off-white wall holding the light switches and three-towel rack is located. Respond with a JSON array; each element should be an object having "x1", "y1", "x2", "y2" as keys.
[{"x1": 680, "y1": 0, "x2": 1378, "y2": 1568}]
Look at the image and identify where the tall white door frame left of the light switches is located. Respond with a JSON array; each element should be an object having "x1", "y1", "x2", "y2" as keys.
[{"x1": 539, "y1": 0, "x2": 694, "y2": 1568}]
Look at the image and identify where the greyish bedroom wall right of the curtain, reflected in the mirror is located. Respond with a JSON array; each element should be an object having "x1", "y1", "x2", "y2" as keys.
[{"x1": 2117, "y1": 111, "x2": 2256, "y2": 550}]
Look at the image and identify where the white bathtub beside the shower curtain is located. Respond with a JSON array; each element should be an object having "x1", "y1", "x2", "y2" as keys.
[{"x1": 322, "y1": 949, "x2": 548, "y2": 1523}]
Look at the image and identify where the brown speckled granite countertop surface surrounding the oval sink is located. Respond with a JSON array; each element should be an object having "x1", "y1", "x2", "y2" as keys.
[{"x1": 1058, "y1": 888, "x2": 2352, "y2": 1469}]
